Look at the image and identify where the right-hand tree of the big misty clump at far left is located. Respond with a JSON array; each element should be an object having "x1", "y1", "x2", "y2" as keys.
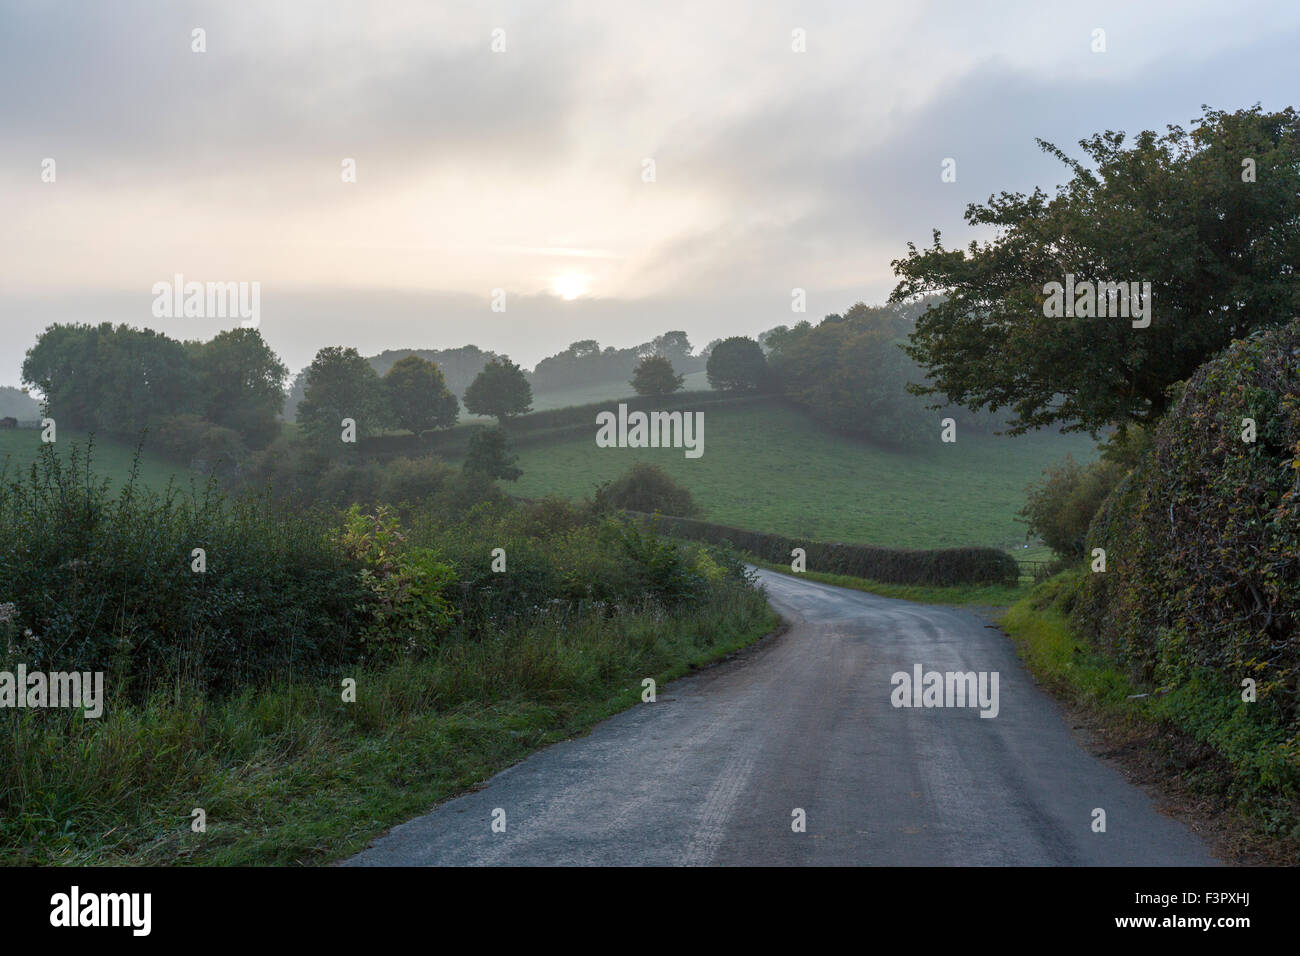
[{"x1": 186, "y1": 329, "x2": 289, "y2": 447}]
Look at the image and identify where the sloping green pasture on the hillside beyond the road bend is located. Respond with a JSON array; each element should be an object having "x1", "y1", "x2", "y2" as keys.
[{"x1": 511, "y1": 399, "x2": 1097, "y2": 559}]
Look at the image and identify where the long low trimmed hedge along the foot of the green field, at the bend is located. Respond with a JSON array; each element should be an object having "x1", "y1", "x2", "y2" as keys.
[{"x1": 628, "y1": 511, "x2": 1021, "y2": 587}]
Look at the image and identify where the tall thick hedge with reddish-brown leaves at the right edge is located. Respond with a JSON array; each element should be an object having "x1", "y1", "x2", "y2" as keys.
[{"x1": 1075, "y1": 320, "x2": 1300, "y2": 750}]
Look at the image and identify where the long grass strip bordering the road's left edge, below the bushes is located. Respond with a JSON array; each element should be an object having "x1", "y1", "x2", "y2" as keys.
[{"x1": 0, "y1": 589, "x2": 776, "y2": 865}]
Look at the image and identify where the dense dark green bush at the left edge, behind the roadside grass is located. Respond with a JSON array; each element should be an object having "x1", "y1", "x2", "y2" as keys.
[{"x1": 0, "y1": 446, "x2": 364, "y2": 698}]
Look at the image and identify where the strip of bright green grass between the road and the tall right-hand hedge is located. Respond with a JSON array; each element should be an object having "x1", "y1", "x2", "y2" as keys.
[{"x1": 998, "y1": 572, "x2": 1300, "y2": 864}]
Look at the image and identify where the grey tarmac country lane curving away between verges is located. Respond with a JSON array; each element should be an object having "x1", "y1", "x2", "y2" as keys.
[{"x1": 345, "y1": 571, "x2": 1217, "y2": 866}]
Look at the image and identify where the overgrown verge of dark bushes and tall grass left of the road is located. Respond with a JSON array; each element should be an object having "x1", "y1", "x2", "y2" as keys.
[{"x1": 0, "y1": 451, "x2": 775, "y2": 864}]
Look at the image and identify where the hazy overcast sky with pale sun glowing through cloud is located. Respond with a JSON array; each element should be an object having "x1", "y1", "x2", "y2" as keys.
[{"x1": 0, "y1": 0, "x2": 1300, "y2": 384}]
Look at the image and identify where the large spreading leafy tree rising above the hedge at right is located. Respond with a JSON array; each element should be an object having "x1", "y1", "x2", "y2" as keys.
[{"x1": 891, "y1": 105, "x2": 1300, "y2": 434}]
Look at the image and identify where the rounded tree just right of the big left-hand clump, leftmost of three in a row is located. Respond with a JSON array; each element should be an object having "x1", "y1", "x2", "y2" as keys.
[{"x1": 298, "y1": 346, "x2": 389, "y2": 450}]
